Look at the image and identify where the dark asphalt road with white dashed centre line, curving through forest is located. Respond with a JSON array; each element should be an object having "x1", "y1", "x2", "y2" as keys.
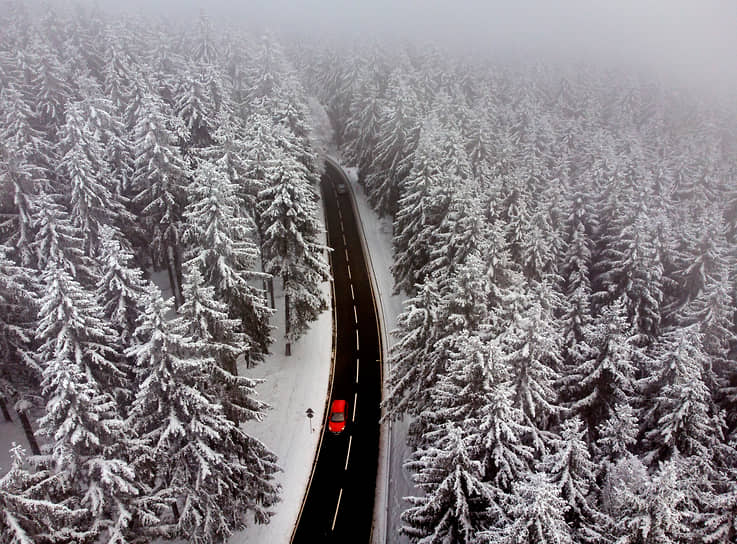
[{"x1": 292, "y1": 163, "x2": 381, "y2": 544}]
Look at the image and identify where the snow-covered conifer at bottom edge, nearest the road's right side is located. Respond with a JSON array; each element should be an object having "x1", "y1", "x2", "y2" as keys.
[{"x1": 401, "y1": 423, "x2": 499, "y2": 544}]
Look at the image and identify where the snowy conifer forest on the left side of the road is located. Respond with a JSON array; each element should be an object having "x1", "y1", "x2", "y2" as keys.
[{"x1": 0, "y1": 2, "x2": 329, "y2": 544}]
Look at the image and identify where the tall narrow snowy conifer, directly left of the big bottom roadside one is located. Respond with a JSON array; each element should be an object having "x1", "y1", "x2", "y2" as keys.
[{"x1": 37, "y1": 263, "x2": 140, "y2": 543}]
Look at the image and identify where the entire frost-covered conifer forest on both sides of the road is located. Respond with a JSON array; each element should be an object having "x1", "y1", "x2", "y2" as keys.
[{"x1": 0, "y1": 0, "x2": 737, "y2": 544}]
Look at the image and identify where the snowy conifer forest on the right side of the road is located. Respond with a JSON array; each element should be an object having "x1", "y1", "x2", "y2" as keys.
[{"x1": 300, "y1": 31, "x2": 737, "y2": 544}]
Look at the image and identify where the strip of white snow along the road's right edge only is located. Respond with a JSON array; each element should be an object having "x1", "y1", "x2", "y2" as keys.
[{"x1": 345, "y1": 168, "x2": 416, "y2": 544}]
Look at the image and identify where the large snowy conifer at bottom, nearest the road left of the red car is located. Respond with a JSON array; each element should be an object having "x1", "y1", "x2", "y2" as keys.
[{"x1": 127, "y1": 290, "x2": 278, "y2": 543}]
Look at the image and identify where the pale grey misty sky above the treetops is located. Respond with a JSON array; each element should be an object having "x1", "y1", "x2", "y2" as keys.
[{"x1": 108, "y1": 0, "x2": 737, "y2": 88}]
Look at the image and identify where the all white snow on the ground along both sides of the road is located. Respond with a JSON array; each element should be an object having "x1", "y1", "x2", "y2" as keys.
[{"x1": 0, "y1": 160, "x2": 402, "y2": 544}]
